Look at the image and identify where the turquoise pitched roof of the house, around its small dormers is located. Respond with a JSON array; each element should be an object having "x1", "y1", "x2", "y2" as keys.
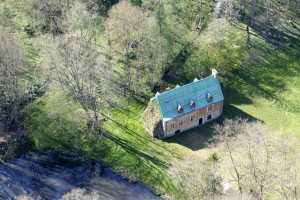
[{"x1": 155, "y1": 75, "x2": 224, "y2": 121}]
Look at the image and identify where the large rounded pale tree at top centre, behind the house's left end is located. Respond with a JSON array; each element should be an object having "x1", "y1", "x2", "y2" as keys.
[{"x1": 106, "y1": 1, "x2": 166, "y2": 97}]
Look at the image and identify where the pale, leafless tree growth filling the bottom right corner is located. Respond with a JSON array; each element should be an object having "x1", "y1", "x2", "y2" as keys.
[{"x1": 216, "y1": 119, "x2": 300, "y2": 200}]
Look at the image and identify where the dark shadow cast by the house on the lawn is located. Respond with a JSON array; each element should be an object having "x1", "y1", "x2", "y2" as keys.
[{"x1": 165, "y1": 104, "x2": 258, "y2": 151}]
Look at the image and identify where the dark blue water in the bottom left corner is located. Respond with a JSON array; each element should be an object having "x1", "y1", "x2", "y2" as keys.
[{"x1": 0, "y1": 153, "x2": 159, "y2": 200}]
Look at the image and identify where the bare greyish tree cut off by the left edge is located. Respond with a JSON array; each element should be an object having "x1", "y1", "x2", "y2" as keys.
[{"x1": 0, "y1": 27, "x2": 24, "y2": 129}]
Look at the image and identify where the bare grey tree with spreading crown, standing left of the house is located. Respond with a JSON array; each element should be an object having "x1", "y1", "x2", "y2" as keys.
[{"x1": 53, "y1": 36, "x2": 105, "y2": 131}]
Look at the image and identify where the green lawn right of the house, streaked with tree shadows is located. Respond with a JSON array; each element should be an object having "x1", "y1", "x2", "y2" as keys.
[{"x1": 225, "y1": 34, "x2": 300, "y2": 136}]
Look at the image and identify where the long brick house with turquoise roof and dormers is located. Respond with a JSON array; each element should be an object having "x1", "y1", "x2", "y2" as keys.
[{"x1": 152, "y1": 69, "x2": 224, "y2": 138}]
